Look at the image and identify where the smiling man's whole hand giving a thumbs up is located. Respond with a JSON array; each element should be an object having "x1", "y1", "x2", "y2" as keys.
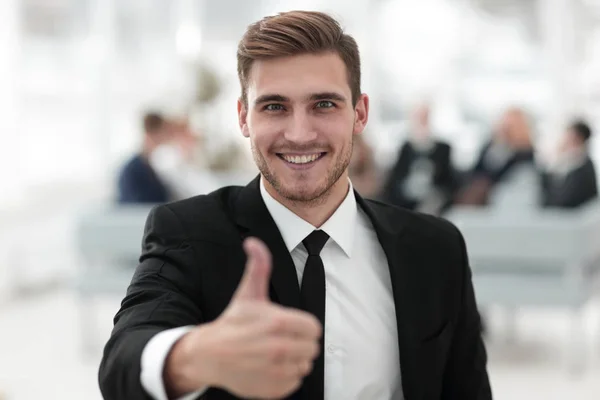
[{"x1": 164, "y1": 238, "x2": 322, "y2": 399}]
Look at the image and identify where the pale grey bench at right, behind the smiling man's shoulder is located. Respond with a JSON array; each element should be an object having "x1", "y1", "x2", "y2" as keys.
[{"x1": 447, "y1": 202, "x2": 600, "y2": 370}]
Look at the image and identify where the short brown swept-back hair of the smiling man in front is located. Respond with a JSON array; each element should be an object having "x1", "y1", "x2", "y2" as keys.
[{"x1": 237, "y1": 11, "x2": 361, "y2": 106}]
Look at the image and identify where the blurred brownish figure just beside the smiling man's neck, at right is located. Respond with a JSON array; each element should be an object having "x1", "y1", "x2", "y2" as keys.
[{"x1": 349, "y1": 133, "x2": 379, "y2": 198}]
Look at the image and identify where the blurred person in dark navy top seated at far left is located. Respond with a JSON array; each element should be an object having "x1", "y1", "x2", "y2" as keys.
[{"x1": 117, "y1": 112, "x2": 172, "y2": 204}]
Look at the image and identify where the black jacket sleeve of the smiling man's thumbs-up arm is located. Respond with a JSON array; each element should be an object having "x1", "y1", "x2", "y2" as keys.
[{"x1": 99, "y1": 206, "x2": 203, "y2": 400}]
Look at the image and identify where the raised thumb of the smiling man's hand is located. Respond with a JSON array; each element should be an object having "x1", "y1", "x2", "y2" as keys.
[{"x1": 233, "y1": 238, "x2": 271, "y2": 300}]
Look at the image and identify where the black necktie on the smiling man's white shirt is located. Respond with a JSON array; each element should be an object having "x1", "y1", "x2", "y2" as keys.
[{"x1": 300, "y1": 230, "x2": 329, "y2": 400}]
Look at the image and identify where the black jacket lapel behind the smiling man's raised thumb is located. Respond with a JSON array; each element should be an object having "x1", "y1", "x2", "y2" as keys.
[{"x1": 234, "y1": 176, "x2": 300, "y2": 308}]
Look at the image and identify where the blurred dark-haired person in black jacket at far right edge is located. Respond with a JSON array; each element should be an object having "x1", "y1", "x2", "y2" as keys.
[{"x1": 541, "y1": 121, "x2": 598, "y2": 208}]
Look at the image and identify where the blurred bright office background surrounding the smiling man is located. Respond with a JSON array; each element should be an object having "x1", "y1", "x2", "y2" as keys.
[{"x1": 0, "y1": 0, "x2": 600, "y2": 400}]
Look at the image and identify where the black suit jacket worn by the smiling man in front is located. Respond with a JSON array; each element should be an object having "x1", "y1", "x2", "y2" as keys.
[{"x1": 99, "y1": 179, "x2": 491, "y2": 400}]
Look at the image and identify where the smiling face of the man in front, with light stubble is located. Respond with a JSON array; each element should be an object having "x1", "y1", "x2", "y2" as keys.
[{"x1": 238, "y1": 53, "x2": 369, "y2": 202}]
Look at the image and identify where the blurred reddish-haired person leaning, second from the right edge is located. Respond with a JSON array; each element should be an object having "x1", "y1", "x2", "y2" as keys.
[{"x1": 455, "y1": 108, "x2": 534, "y2": 206}]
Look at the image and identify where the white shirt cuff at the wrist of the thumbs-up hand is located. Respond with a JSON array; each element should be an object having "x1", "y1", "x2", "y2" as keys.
[{"x1": 140, "y1": 326, "x2": 207, "y2": 400}]
